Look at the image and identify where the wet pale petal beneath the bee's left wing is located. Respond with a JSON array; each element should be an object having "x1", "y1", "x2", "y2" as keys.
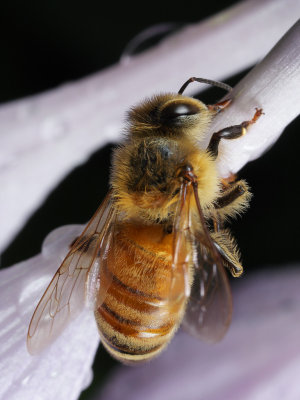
[{"x1": 0, "y1": 226, "x2": 99, "y2": 400}]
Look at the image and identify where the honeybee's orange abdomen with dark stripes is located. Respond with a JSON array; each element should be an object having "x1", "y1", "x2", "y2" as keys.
[{"x1": 95, "y1": 223, "x2": 185, "y2": 363}]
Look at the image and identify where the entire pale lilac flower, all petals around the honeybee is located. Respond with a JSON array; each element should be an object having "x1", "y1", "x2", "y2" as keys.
[{"x1": 0, "y1": 0, "x2": 300, "y2": 400}]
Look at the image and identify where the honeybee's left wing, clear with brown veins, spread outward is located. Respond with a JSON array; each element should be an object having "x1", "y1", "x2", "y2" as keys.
[{"x1": 27, "y1": 194, "x2": 115, "y2": 354}]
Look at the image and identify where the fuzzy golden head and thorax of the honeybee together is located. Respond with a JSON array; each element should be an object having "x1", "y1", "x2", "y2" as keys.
[{"x1": 111, "y1": 93, "x2": 220, "y2": 223}]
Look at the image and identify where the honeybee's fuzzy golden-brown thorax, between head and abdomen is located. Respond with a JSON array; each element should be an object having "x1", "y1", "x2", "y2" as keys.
[{"x1": 111, "y1": 140, "x2": 220, "y2": 222}]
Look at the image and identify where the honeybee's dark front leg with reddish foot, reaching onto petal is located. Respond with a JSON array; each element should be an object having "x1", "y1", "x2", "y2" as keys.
[{"x1": 207, "y1": 108, "x2": 262, "y2": 158}]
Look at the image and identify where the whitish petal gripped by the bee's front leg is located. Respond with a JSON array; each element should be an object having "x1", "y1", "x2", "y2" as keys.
[{"x1": 211, "y1": 21, "x2": 300, "y2": 176}]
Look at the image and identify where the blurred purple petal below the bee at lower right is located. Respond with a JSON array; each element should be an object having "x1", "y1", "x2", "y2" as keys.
[{"x1": 99, "y1": 265, "x2": 300, "y2": 400}]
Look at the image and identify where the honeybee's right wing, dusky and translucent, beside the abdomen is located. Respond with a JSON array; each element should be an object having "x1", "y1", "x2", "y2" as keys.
[{"x1": 179, "y1": 183, "x2": 232, "y2": 342}]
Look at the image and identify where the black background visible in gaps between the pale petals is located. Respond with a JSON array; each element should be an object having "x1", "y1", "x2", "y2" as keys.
[{"x1": 0, "y1": 0, "x2": 300, "y2": 400}]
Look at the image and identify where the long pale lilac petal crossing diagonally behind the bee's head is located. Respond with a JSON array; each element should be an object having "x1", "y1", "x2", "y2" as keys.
[{"x1": 0, "y1": 0, "x2": 300, "y2": 249}]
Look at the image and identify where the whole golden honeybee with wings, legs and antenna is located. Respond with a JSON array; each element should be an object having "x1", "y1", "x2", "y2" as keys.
[{"x1": 27, "y1": 78, "x2": 262, "y2": 364}]
